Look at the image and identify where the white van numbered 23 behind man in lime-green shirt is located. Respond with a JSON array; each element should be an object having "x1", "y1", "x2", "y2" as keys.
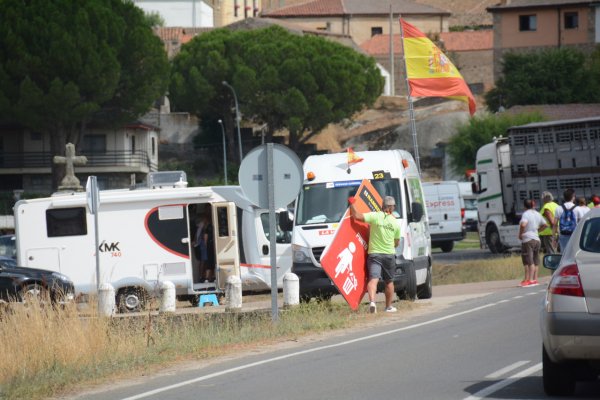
[{"x1": 292, "y1": 150, "x2": 431, "y2": 301}]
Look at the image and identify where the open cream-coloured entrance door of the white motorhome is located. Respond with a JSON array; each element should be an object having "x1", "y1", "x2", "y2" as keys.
[{"x1": 212, "y1": 202, "x2": 240, "y2": 290}]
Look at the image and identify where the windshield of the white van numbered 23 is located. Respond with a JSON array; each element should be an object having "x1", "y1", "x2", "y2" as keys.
[{"x1": 296, "y1": 179, "x2": 402, "y2": 225}]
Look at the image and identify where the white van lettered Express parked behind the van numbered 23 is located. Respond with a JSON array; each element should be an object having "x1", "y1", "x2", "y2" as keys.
[{"x1": 423, "y1": 181, "x2": 466, "y2": 253}]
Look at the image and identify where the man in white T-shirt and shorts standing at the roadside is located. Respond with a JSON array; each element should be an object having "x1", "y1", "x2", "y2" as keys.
[{"x1": 519, "y1": 199, "x2": 547, "y2": 287}]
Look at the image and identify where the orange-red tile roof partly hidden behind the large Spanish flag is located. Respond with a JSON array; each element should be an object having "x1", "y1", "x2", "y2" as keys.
[{"x1": 360, "y1": 30, "x2": 494, "y2": 56}]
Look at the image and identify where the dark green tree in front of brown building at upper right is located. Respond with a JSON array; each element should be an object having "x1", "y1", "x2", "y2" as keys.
[{"x1": 485, "y1": 47, "x2": 599, "y2": 111}]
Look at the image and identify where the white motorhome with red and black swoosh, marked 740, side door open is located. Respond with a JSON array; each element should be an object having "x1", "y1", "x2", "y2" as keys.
[{"x1": 15, "y1": 173, "x2": 291, "y2": 312}]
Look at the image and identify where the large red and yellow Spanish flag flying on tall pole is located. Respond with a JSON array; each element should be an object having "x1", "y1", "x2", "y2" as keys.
[{"x1": 400, "y1": 18, "x2": 475, "y2": 115}]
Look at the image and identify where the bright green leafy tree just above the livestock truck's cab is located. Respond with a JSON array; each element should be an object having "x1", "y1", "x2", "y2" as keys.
[{"x1": 447, "y1": 113, "x2": 544, "y2": 175}]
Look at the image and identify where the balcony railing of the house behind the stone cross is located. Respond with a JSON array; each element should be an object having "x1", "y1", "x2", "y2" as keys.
[{"x1": 0, "y1": 150, "x2": 158, "y2": 171}]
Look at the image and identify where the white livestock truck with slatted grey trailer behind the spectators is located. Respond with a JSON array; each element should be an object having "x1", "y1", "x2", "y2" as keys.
[{"x1": 476, "y1": 117, "x2": 600, "y2": 253}]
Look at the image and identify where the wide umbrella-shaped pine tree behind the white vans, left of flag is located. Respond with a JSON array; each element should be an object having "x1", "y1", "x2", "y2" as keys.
[{"x1": 170, "y1": 26, "x2": 384, "y2": 159}]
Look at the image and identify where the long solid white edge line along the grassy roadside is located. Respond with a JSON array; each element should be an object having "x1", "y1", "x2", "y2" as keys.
[{"x1": 122, "y1": 296, "x2": 541, "y2": 400}]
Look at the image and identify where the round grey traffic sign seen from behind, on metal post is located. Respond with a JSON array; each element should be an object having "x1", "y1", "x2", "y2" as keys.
[{"x1": 238, "y1": 143, "x2": 302, "y2": 321}]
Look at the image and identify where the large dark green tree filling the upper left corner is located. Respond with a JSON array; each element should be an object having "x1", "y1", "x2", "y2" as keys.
[{"x1": 0, "y1": 0, "x2": 169, "y2": 188}]
